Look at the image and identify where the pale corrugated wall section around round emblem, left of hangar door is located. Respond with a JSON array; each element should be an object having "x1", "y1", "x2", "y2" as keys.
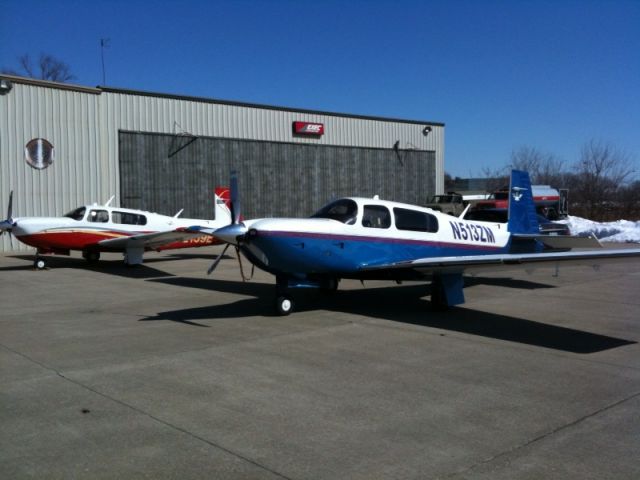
[{"x1": 0, "y1": 82, "x2": 107, "y2": 251}]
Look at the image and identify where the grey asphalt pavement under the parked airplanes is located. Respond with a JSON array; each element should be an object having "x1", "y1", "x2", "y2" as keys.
[{"x1": 0, "y1": 247, "x2": 640, "y2": 480}]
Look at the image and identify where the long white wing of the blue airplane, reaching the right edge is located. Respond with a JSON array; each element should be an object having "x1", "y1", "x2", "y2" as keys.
[{"x1": 361, "y1": 248, "x2": 640, "y2": 277}]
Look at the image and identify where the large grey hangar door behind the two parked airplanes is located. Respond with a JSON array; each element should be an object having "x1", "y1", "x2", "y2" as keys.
[{"x1": 119, "y1": 131, "x2": 435, "y2": 218}]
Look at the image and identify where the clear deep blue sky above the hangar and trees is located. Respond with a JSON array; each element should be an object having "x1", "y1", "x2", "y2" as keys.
[{"x1": 0, "y1": 0, "x2": 640, "y2": 178}]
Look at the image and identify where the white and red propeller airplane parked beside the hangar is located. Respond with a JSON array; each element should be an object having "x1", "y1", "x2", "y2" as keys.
[{"x1": 0, "y1": 187, "x2": 231, "y2": 269}]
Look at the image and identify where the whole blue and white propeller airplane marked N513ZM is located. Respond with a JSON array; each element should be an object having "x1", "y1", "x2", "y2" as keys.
[{"x1": 192, "y1": 170, "x2": 640, "y2": 315}]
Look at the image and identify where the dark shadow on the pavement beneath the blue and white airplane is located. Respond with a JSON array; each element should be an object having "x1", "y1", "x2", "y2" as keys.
[{"x1": 141, "y1": 277, "x2": 636, "y2": 354}]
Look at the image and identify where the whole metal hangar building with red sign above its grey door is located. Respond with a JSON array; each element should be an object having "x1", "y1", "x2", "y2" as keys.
[{"x1": 0, "y1": 75, "x2": 444, "y2": 255}]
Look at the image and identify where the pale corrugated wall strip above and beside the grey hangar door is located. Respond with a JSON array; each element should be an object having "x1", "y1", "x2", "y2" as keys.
[{"x1": 102, "y1": 89, "x2": 444, "y2": 197}]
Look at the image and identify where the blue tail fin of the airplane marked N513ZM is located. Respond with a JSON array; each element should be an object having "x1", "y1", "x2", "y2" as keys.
[{"x1": 507, "y1": 170, "x2": 540, "y2": 234}]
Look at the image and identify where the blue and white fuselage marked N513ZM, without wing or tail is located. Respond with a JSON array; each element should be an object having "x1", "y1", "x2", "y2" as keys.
[{"x1": 241, "y1": 198, "x2": 510, "y2": 278}]
